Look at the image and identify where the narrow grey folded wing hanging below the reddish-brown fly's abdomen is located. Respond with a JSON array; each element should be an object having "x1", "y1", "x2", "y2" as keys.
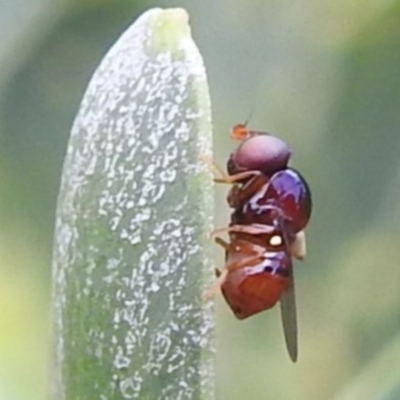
[{"x1": 280, "y1": 273, "x2": 298, "y2": 362}]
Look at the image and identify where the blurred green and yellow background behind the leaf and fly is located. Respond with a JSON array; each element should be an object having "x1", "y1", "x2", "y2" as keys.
[{"x1": 0, "y1": 0, "x2": 400, "y2": 400}]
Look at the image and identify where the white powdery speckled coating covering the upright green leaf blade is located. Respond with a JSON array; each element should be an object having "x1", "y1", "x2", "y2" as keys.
[{"x1": 53, "y1": 10, "x2": 214, "y2": 400}]
